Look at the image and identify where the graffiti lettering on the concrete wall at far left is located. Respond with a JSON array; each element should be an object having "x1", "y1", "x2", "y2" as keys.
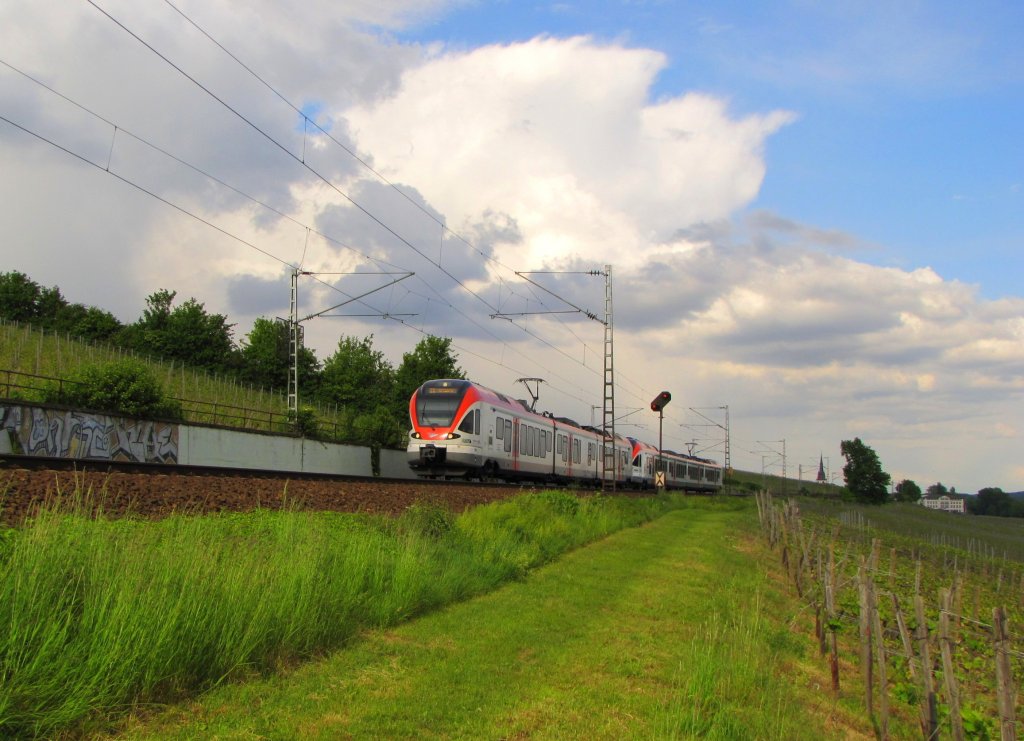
[{"x1": 0, "y1": 404, "x2": 178, "y2": 464}]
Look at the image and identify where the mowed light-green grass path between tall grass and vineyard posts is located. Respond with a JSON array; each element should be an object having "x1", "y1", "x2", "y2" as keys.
[{"x1": 112, "y1": 505, "x2": 857, "y2": 739}]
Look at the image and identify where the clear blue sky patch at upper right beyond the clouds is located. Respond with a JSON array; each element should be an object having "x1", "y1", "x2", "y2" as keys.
[{"x1": 396, "y1": 0, "x2": 1024, "y2": 298}]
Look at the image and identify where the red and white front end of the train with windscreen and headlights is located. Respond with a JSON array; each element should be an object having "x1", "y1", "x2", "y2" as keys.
[{"x1": 406, "y1": 379, "x2": 483, "y2": 477}]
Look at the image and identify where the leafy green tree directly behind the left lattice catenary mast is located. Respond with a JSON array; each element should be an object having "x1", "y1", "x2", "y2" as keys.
[{"x1": 240, "y1": 316, "x2": 319, "y2": 390}]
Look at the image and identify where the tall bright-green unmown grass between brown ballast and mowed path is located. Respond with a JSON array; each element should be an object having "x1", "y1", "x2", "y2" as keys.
[{"x1": 0, "y1": 492, "x2": 683, "y2": 738}]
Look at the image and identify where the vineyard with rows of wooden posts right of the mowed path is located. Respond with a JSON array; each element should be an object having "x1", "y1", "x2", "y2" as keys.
[{"x1": 758, "y1": 493, "x2": 1024, "y2": 739}]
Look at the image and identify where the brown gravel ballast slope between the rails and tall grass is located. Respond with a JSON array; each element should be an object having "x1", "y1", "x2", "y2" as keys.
[{"x1": 0, "y1": 468, "x2": 520, "y2": 525}]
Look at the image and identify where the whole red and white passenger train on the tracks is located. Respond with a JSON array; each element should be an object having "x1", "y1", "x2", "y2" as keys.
[{"x1": 407, "y1": 379, "x2": 722, "y2": 492}]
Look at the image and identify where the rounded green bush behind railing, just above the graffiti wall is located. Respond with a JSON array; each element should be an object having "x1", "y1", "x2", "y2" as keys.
[{"x1": 43, "y1": 359, "x2": 182, "y2": 420}]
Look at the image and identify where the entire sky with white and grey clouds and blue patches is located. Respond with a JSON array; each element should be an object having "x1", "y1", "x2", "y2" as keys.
[{"x1": 0, "y1": 0, "x2": 1024, "y2": 492}]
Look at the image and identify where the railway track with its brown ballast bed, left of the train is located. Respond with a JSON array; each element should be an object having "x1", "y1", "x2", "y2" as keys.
[{"x1": 0, "y1": 455, "x2": 536, "y2": 525}]
